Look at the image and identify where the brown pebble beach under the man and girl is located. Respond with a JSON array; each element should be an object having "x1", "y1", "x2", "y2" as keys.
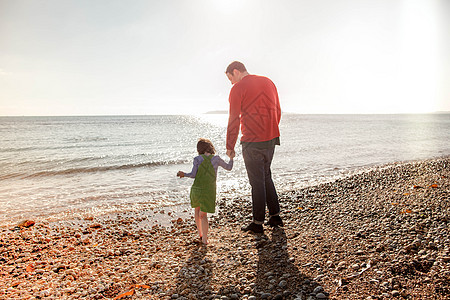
[{"x1": 0, "y1": 157, "x2": 450, "y2": 299}]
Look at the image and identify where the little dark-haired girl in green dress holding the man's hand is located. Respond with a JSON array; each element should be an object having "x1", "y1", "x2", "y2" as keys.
[{"x1": 177, "y1": 138, "x2": 234, "y2": 245}]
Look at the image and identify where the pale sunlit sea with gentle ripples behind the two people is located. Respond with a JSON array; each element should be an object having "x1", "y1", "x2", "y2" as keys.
[{"x1": 0, "y1": 113, "x2": 450, "y2": 225}]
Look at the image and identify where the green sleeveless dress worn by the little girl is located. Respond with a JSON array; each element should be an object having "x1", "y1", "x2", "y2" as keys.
[{"x1": 190, "y1": 154, "x2": 216, "y2": 213}]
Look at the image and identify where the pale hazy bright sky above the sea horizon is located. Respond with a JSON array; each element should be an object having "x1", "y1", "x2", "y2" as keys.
[{"x1": 0, "y1": 0, "x2": 450, "y2": 115}]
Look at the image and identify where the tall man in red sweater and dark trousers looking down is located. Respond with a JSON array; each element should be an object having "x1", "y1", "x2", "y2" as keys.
[{"x1": 225, "y1": 61, "x2": 283, "y2": 233}]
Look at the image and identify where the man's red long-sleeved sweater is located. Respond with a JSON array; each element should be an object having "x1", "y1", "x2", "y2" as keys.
[{"x1": 227, "y1": 75, "x2": 281, "y2": 150}]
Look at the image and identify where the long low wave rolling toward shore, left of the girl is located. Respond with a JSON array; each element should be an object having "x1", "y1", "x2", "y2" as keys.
[{"x1": 0, "y1": 160, "x2": 188, "y2": 181}]
